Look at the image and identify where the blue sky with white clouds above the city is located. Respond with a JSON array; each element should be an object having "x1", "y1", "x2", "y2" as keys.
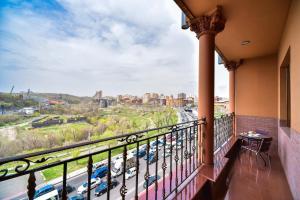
[{"x1": 0, "y1": 0, "x2": 228, "y2": 97}]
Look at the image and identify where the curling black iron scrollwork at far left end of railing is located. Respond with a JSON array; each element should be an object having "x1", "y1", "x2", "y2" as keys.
[{"x1": 0, "y1": 156, "x2": 53, "y2": 180}]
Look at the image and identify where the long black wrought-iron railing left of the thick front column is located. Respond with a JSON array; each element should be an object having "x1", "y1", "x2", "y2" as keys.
[{"x1": 0, "y1": 118, "x2": 206, "y2": 200}]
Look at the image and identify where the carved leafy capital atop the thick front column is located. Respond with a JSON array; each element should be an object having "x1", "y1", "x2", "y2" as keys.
[{"x1": 188, "y1": 6, "x2": 226, "y2": 38}]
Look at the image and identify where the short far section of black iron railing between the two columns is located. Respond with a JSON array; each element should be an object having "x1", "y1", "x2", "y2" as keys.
[{"x1": 214, "y1": 113, "x2": 234, "y2": 151}]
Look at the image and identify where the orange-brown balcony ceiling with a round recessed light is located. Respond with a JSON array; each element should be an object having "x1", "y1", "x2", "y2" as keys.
[{"x1": 175, "y1": 0, "x2": 290, "y2": 60}]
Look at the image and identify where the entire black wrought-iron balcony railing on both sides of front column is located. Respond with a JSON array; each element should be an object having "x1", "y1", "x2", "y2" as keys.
[{"x1": 0, "y1": 114, "x2": 234, "y2": 199}]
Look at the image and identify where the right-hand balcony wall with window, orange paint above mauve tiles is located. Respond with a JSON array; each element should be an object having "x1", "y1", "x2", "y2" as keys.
[{"x1": 277, "y1": 0, "x2": 300, "y2": 199}]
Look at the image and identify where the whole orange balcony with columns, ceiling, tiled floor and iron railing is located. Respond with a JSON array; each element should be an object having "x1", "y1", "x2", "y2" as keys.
[{"x1": 0, "y1": 0, "x2": 300, "y2": 200}]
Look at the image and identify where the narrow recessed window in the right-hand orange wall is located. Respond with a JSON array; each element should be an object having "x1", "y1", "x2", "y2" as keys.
[{"x1": 280, "y1": 49, "x2": 291, "y2": 127}]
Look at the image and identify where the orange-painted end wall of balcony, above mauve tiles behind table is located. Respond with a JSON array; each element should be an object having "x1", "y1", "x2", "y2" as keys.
[{"x1": 235, "y1": 55, "x2": 278, "y2": 118}]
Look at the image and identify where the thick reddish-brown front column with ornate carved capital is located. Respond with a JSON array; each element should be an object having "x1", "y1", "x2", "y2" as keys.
[{"x1": 189, "y1": 6, "x2": 225, "y2": 165}]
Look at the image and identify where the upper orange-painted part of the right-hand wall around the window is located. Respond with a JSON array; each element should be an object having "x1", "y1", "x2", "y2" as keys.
[{"x1": 278, "y1": 0, "x2": 300, "y2": 132}]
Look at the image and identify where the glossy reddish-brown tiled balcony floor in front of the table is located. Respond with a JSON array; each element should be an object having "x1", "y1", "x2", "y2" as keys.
[{"x1": 225, "y1": 152, "x2": 293, "y2": 200}]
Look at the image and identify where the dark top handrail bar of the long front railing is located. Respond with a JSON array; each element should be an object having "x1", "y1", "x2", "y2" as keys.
[{"x1": 0, "y1": 118, "x2": 205, "y2": 164}]
